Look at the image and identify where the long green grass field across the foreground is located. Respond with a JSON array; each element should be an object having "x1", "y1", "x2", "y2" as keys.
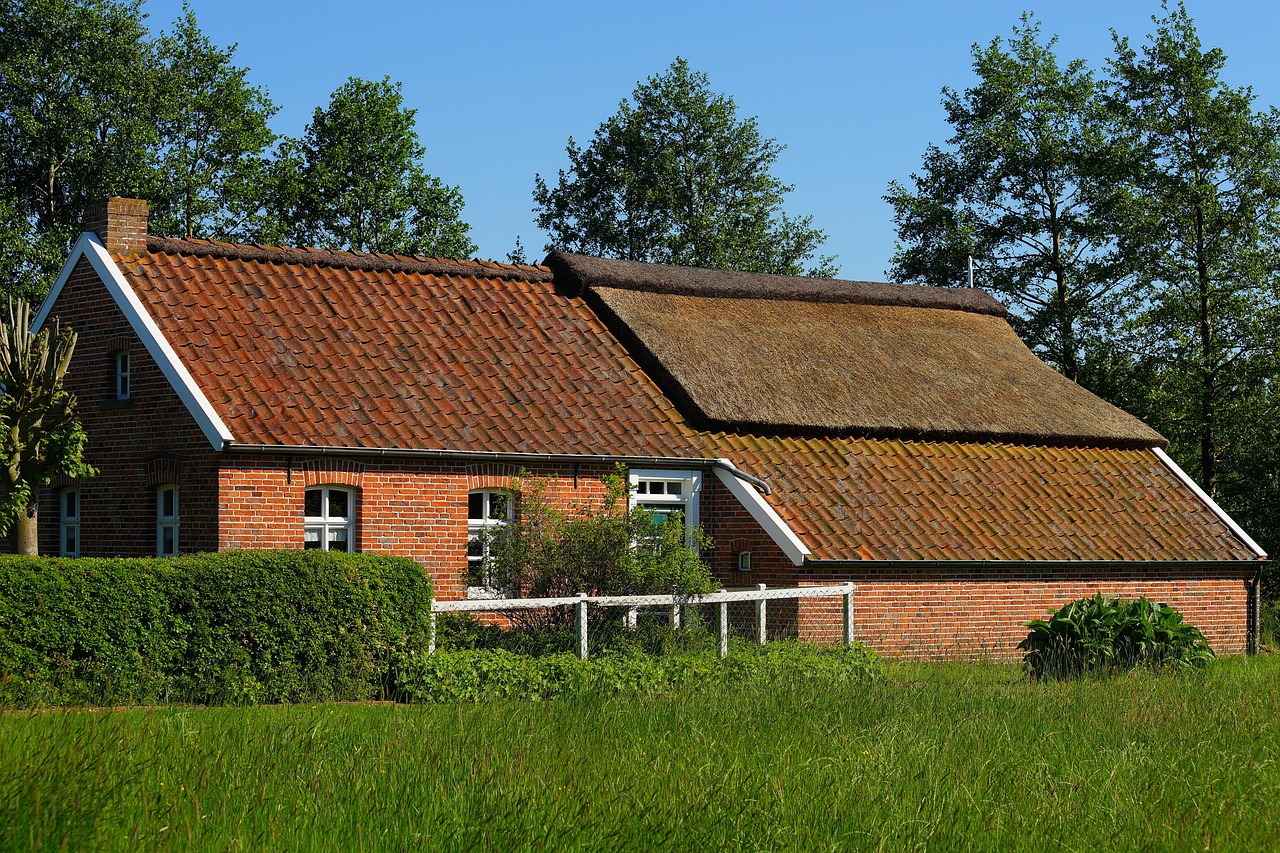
[{"x1": 0, "y1": 656, "x2": 1280, "y2": 850}]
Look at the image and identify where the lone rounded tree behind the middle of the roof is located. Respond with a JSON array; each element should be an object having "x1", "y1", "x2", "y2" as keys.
[{"x1": 534, "y1": 58, "x2": 836, "y2": 275}]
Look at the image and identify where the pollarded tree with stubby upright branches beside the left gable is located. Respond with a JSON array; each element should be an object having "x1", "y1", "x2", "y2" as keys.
[{"x1": 0, "y1": 300, "x2": 97, "y2": 556}]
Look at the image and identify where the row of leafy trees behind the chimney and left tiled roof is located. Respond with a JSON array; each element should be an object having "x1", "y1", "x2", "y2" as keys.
[{"x1": 0, "y1": 0, "x2": 475, "y2": 300}]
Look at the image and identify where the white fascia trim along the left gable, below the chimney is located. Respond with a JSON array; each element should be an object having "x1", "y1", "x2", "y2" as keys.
[{"x1": 31, "y1": 231, "x2": 233, "y2": 451}]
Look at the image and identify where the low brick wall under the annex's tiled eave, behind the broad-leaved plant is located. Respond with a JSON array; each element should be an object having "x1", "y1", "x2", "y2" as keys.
[{"x1": 703, "y1": 476, "x2": 1257, "y2": 658}]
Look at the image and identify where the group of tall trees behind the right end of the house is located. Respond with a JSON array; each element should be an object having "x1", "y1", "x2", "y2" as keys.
[{"x1": 886, "y1": 4, "x2": 1280, "y2": 571}]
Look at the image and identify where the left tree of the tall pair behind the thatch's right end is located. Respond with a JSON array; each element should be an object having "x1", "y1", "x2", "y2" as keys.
[{"x1": 884, "y1": 15, "x2": 1128, "y2": 380}]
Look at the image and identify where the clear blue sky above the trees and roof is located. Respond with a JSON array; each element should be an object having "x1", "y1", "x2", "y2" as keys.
[{"x1": 143, "y1": 0, "x2": 1280, "y2": 279}]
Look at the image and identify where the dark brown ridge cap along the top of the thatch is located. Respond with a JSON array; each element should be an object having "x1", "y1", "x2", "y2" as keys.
[{"x1": 543, "y1": 251, "x2": 1009, "y2": 318}]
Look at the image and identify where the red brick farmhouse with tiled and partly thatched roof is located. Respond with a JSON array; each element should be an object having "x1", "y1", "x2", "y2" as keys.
[{"x1": 36, "y1": 199, "x2": 1265, "y2": 657}]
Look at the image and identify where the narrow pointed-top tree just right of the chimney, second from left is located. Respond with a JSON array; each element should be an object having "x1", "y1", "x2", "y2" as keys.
[{"x1": 148, "y1": 5, "x2": 276, "y2": 240}]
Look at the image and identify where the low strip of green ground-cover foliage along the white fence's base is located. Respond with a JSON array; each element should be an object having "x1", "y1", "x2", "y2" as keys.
[{"x1": 399, "y1": 643, "x2": 883, "y2": 702}]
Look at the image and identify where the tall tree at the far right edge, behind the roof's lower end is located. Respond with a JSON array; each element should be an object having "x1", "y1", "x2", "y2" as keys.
[{"x1": 1110, "y1": 4, "x2": 1280, "y2": 501}]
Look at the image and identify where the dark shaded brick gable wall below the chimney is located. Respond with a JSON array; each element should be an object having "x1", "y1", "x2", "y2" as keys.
[{"x1": 40, "y1": 260, "x2": 218, "y2": 557}]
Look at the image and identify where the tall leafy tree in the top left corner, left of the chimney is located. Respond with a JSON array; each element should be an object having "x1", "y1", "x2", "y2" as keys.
[{"x1": 0, "y1": 0, "x2": 156, "y2": 298}]
